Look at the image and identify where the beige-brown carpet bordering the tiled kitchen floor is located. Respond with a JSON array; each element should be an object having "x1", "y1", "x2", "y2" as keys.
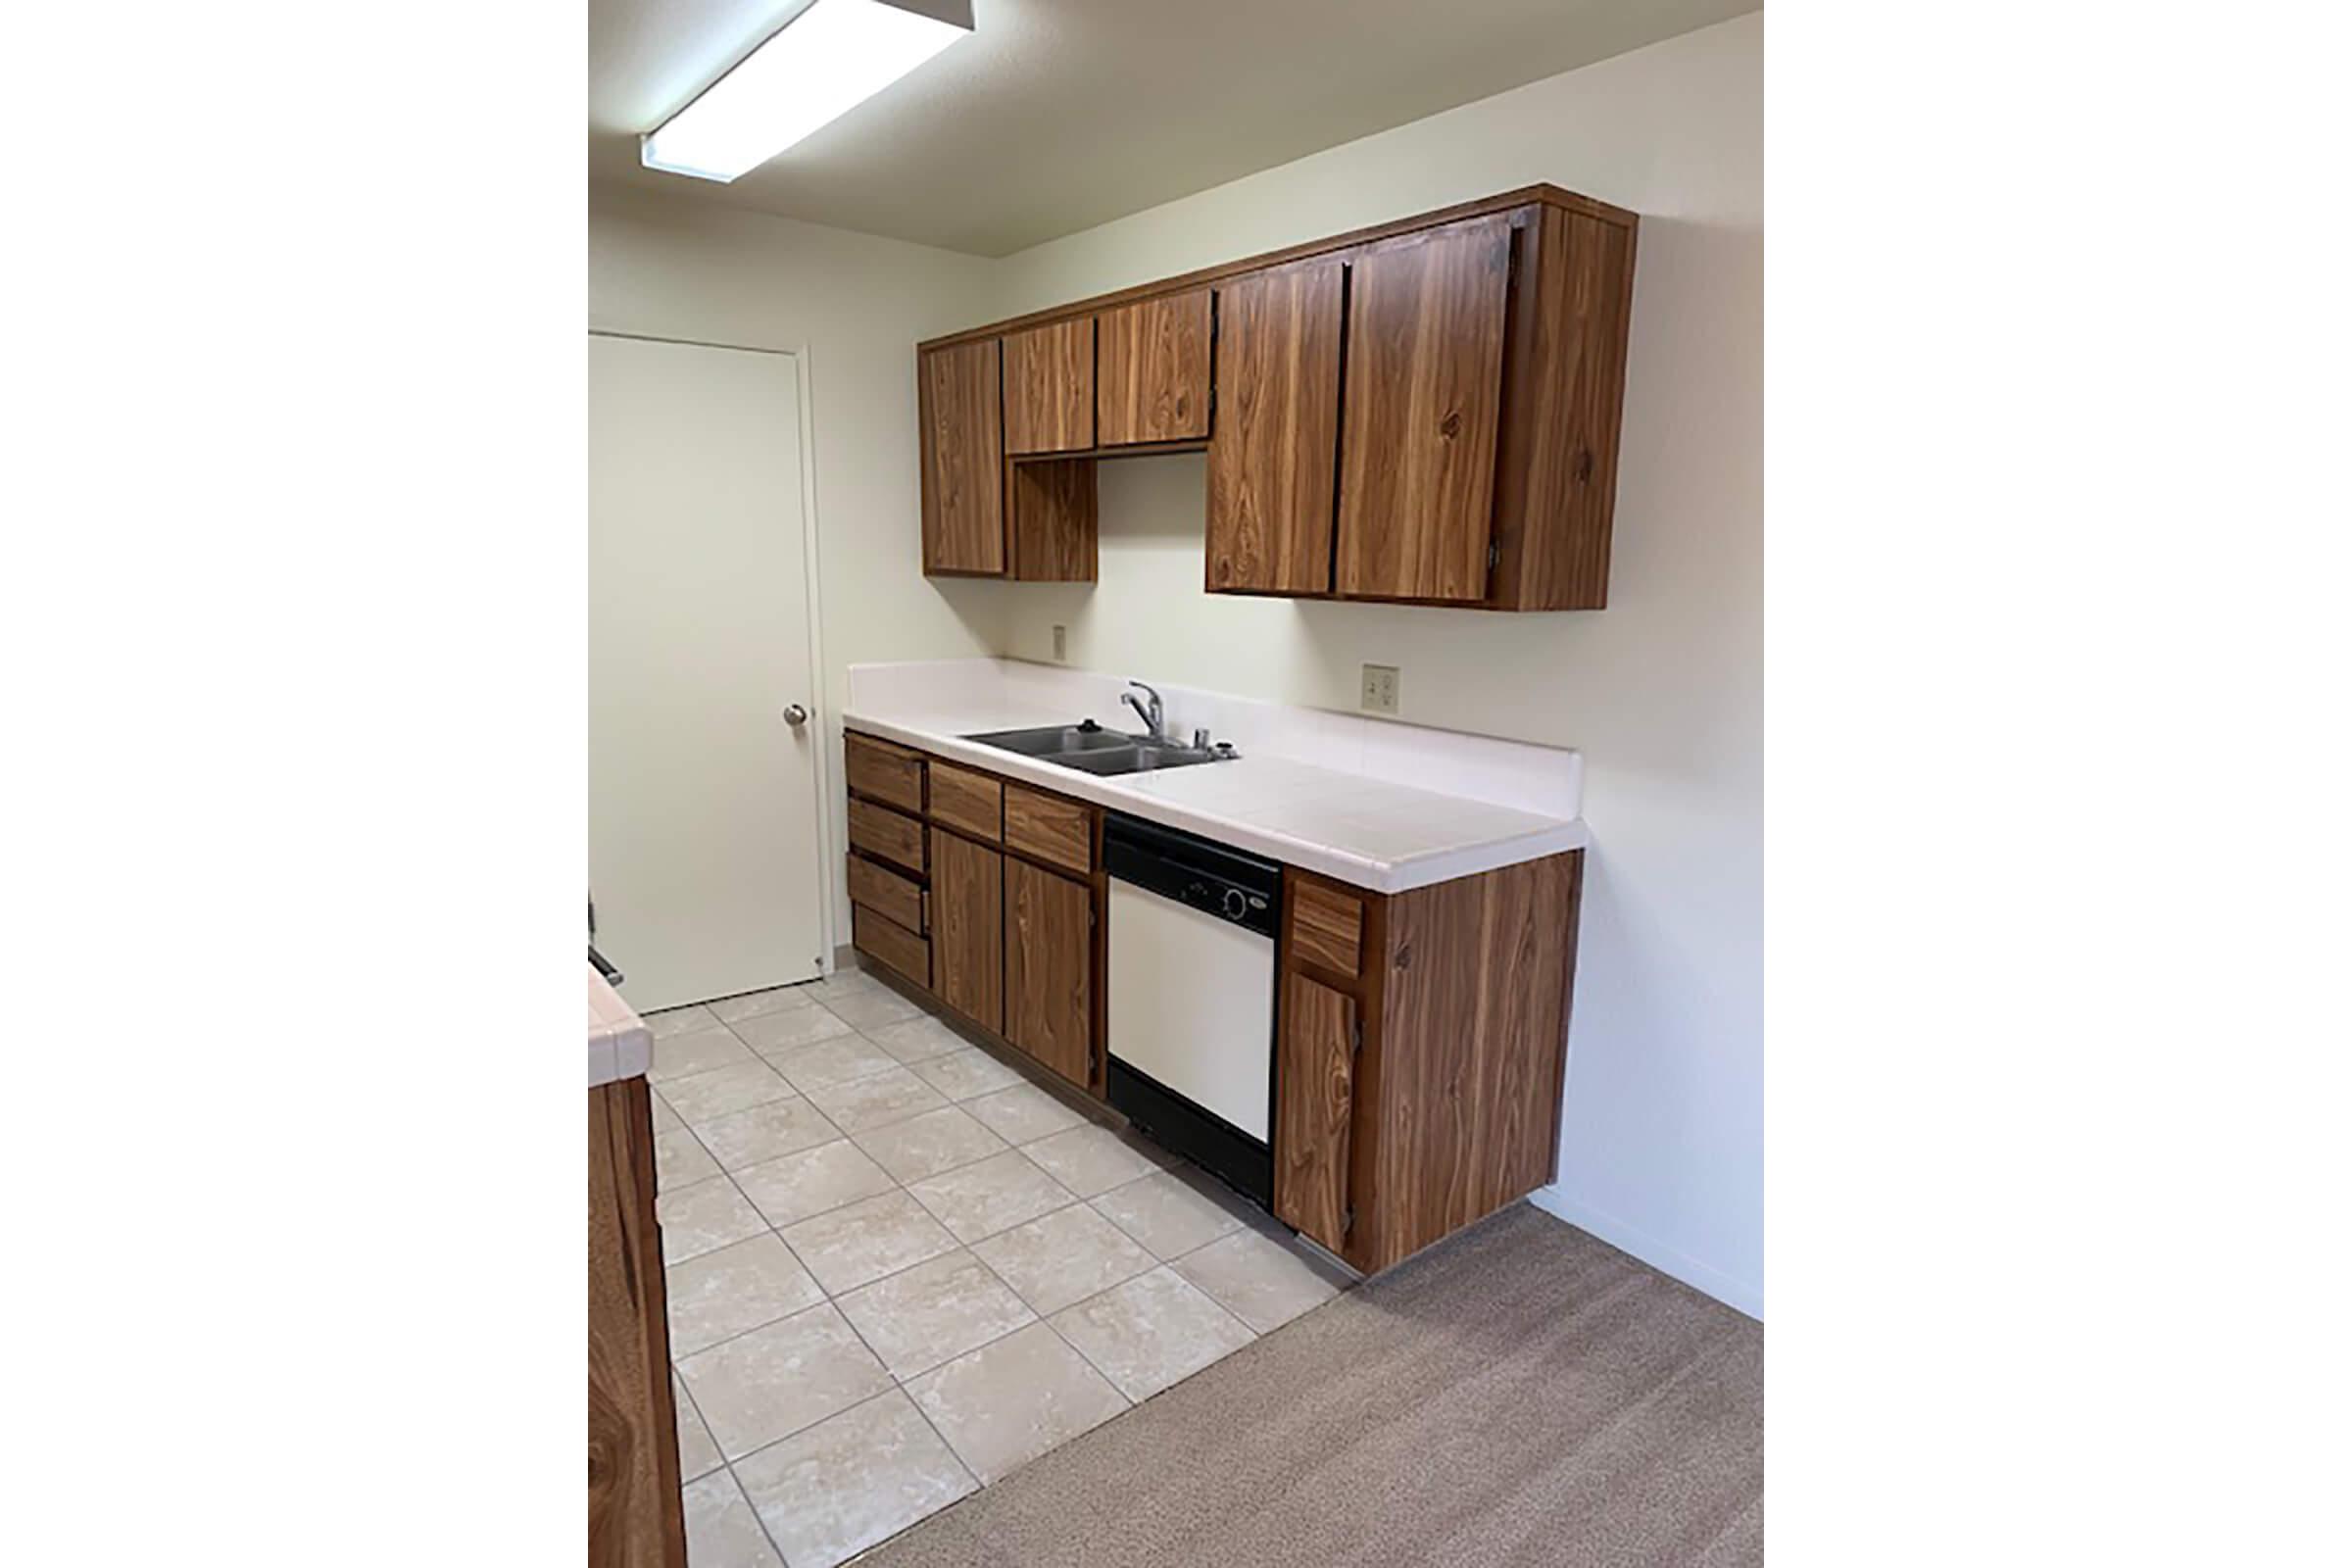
[{"x1": 860, "y1": 1203, "x2": 1764, "y2": 1568}]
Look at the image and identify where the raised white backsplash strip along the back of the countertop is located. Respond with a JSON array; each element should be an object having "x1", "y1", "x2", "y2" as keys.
[{"x1": 849, "y1": 659, "x2": 1586, "y2": 818}]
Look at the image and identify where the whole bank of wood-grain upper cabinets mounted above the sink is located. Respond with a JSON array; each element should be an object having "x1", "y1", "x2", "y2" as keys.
[{"x1": 924, "y1": 186, "x2": 1637, "y2": 609}]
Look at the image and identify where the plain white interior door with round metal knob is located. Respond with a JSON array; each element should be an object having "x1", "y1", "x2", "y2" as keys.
[{"x1": 588, "y1": 334, "x2": 828, "y2": 1010}]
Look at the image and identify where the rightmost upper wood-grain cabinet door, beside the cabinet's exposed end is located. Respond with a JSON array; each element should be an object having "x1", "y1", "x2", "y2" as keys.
[{"x1": 1339, "y1": 217, "x2": 1510, "y2": 602}]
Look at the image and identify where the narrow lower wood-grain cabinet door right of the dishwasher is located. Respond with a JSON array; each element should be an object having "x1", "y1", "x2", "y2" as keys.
[{"x1": 1275, "y1": 973, "x2": 1354, "y2": 1253}]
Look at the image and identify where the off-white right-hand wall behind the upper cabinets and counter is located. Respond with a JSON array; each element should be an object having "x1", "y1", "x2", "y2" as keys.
[{"x1": 978, "y1": 14, "x2": 1764, "y2": 1314}]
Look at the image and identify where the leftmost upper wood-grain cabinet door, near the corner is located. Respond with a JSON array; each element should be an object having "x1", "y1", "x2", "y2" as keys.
[{"x1": 915, "y1": 338, "x2": 1004, "y2": 576}]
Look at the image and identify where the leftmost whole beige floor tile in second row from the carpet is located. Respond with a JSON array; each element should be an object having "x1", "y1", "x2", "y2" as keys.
[{"x1": 677, "y1": 1302, "x2": 892, "y2": 1460}]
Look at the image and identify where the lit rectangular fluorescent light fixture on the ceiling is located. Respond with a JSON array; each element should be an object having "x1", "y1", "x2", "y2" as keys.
[{"x1": 637, "y1": 0, "x2": 971, "y2": 181}]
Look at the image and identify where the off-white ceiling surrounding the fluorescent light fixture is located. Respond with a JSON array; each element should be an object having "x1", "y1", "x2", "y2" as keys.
[{"x1": 588, "y1": 0, "x2": 1762, "y2": 256}]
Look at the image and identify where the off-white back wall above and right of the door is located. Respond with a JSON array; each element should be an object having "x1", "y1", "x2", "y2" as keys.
[{"x1": 588, "y1": 186, "x2": 1006, "y2": 943}]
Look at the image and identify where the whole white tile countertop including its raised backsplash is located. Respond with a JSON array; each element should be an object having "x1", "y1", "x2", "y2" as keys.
[{"x1": 842, "y1": 659, "x2": 1590, "y2": 894}]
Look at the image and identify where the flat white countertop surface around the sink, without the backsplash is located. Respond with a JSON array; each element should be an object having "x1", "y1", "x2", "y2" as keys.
[{"x1": 842, "y1": 701, "x2": 1590, "y2": 894}]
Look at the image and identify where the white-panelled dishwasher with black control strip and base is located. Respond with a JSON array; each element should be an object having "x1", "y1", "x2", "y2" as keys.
[{"x1": 1103, "y1": 813, "x2": 1282, "y2": 1206}]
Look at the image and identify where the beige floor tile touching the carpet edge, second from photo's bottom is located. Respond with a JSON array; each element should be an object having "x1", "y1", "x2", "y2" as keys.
[{"x1": 906, "y1": 1324, "x2": 1127, "y2": 1484}]
